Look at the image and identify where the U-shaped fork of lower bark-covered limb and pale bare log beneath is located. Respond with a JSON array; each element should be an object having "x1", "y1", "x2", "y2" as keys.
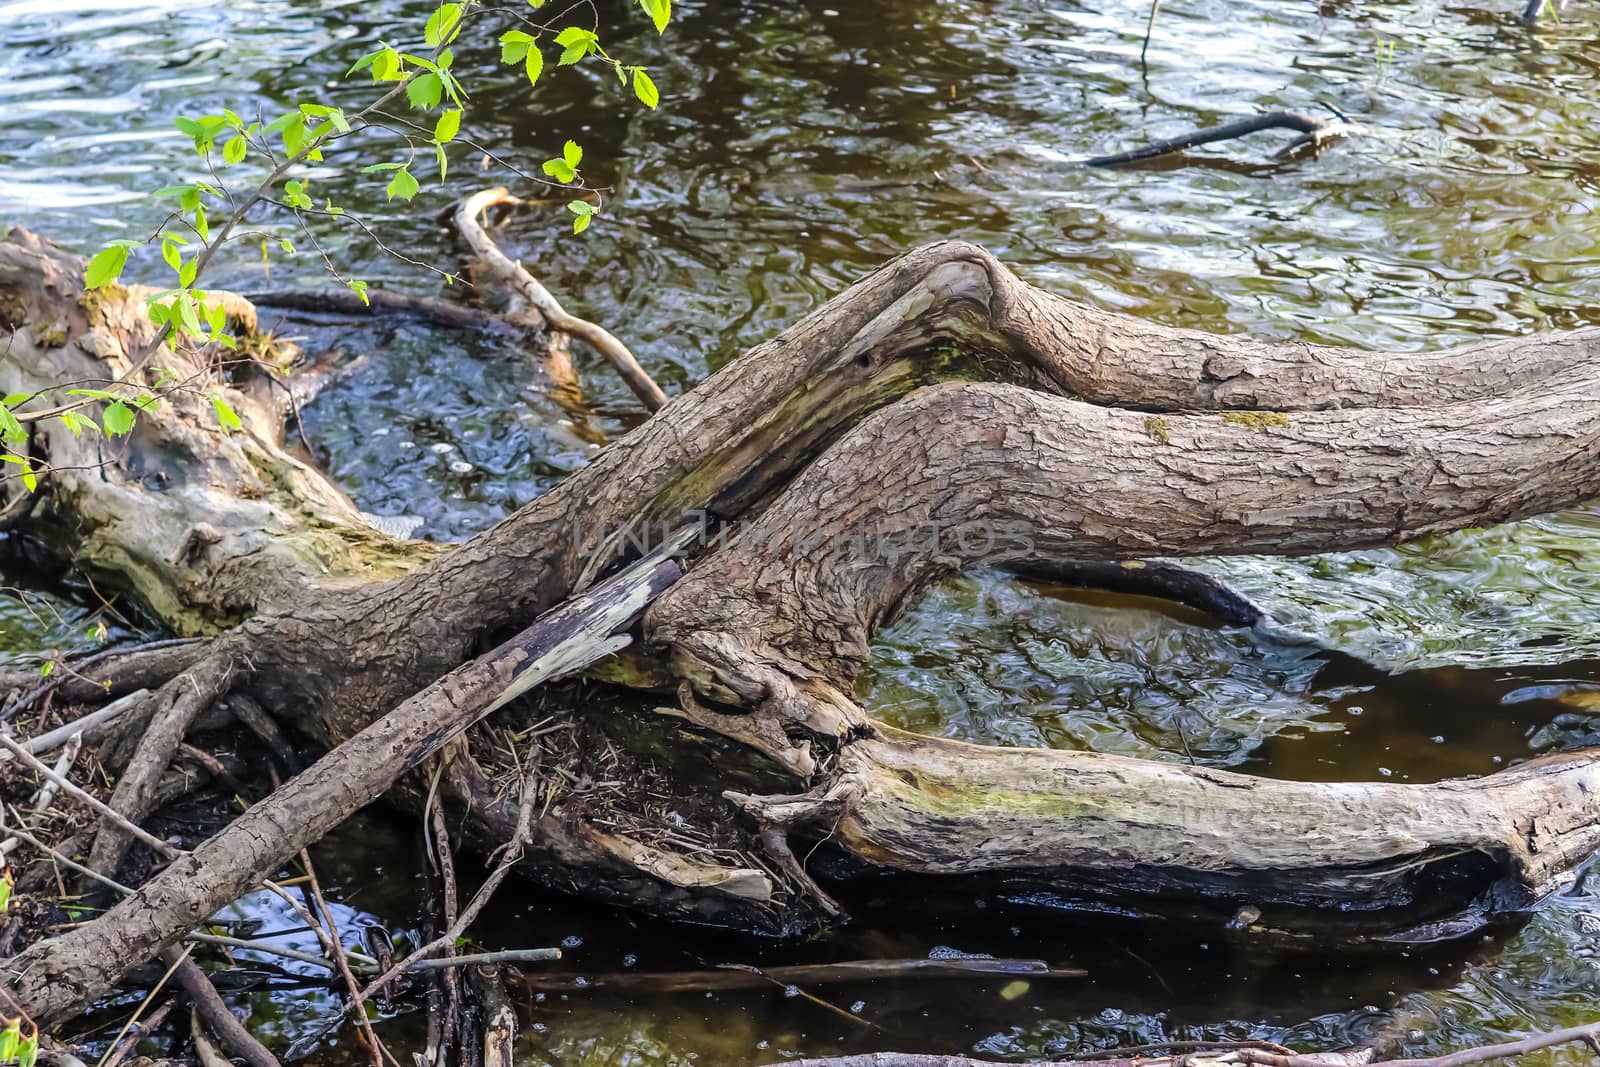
[{"x1": 646, "y1": 377, "x2": 1600, "y2": 928}]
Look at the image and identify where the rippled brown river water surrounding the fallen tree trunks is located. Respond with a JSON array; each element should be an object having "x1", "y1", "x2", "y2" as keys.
[{"x1": 0, "y1": 0, "x2": 1600, "y2": 1067}]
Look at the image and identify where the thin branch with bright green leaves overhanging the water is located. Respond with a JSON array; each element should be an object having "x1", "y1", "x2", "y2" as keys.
[{"x1": 0, "y1": 0, "x2": 672, "y2": 493}]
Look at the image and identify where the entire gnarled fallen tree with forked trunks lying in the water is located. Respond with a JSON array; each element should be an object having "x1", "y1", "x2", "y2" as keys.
[{"x1": 0, "y1": 223, "x2": 1600, "y2": 1021}]
